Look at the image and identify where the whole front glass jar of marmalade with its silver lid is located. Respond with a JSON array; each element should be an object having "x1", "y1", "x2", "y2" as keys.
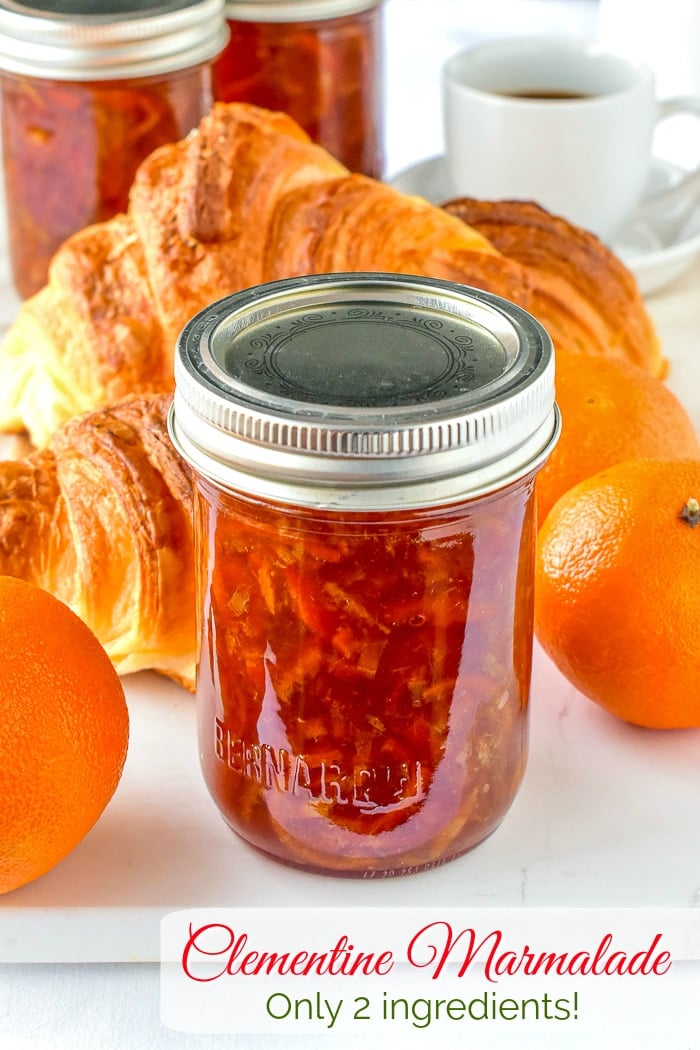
[{"x1": 170, "y1": 274, "x2": 558, "y2": 878}]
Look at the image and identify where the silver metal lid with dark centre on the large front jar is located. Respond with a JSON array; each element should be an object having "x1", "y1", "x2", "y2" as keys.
[{"x1": 170, "y1": 273, "x2": 558, "y2": 510}]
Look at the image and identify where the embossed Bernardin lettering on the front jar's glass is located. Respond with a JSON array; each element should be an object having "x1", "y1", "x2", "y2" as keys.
[{"x1": 214, "y1": 718, "x2": 425, "y2": 813}]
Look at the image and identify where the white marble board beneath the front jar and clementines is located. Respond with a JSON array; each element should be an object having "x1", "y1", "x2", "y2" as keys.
[{"x1": 0, "y1": 625, "x2": 700, "y2": 961}]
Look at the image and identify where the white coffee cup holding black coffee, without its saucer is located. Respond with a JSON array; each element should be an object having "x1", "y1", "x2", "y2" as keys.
[{"x1": 443, "y1": 36, "x2": 700, "y2": 240}]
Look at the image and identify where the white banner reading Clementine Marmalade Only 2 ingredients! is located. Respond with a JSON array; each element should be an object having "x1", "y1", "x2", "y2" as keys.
[{"x1": 161, "y1": 907, "x2": 700, "y2": 1050}]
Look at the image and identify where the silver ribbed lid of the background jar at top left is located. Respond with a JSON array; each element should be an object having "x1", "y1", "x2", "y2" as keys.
[{"x1": 0, "y1": 0, "x2": 228, "y2": 81}]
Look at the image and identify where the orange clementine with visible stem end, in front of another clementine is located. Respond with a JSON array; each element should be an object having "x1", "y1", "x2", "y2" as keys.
[{"x1": 535, "y1": 459, "x2": 700, "y2": 729}]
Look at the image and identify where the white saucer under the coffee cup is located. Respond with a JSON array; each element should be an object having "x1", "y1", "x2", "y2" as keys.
[{"x1": 390, "y1": 155, "x2": 700, "y2": 295}]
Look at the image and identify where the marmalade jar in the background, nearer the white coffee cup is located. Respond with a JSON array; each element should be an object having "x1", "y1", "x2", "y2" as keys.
[{"x1": 214, "y1": 0, "x2": 383, "y2": 179}]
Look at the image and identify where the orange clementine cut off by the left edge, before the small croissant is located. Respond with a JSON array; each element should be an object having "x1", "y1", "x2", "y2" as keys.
[{"x1": 0, "y1": 576, "x2": 129, "y2": 894}]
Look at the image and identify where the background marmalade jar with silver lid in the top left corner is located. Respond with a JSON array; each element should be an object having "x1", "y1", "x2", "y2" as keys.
[{"x1": 0, "y1": 0, "x2": 227, "y2": 296}]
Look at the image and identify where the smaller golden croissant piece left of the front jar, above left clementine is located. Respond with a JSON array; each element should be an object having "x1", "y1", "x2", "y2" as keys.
[{"x1": 0, "y1": 394, "x2": 195, "y2": 690}]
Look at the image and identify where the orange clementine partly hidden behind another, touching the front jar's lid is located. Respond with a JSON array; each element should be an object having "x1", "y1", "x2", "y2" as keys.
[{"x1": 536, "y1": 350, "x2": 700, "y2": 525}]
